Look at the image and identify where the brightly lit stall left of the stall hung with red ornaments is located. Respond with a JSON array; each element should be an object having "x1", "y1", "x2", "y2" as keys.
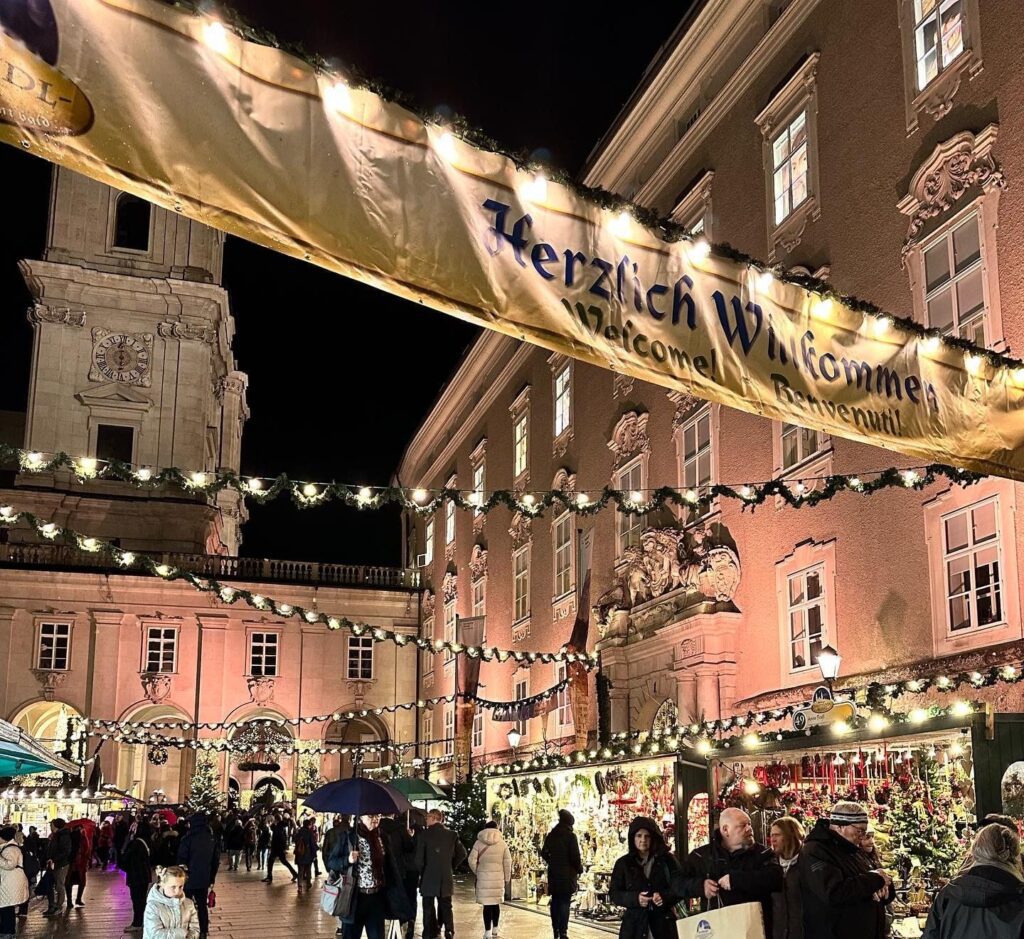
[{"x1": 486, "y1": 755, "x2": 708, "y2": 925}]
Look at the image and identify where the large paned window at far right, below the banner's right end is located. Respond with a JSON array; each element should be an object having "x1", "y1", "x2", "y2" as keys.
[{"x1": 942, "y1": 499, "x2": 1004, "y2": 633}]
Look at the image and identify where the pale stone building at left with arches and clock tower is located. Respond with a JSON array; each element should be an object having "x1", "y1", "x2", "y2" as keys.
[{"x1": 0, "y1": 170, "x2": 418, "y2": 802}]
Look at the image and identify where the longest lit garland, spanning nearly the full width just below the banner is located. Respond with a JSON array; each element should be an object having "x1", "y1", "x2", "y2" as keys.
[{"x1": 0, "y1": 443, "x2": 984, "y2": 518}]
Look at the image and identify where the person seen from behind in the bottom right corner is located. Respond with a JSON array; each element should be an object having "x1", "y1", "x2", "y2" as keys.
[{"x1": 924, "y1": 822, "x2": 1024, "y2": 939}]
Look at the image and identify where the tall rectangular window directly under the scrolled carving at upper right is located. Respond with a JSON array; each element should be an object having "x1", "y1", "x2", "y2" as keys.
[{"x1": 925, "y1": 214, "x2": 985, "y2": 346}]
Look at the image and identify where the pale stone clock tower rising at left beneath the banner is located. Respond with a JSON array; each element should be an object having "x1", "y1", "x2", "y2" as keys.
[{"x1": 11, "y1": 169, "x2": 249, "y2": 555}]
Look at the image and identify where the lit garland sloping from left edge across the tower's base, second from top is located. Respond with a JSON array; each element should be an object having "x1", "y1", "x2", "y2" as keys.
[{"x1": 0, "y1": 505, "x2": 598, "y2": 670}]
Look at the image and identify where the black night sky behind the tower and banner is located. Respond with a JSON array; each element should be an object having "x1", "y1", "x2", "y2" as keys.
[{"x1": 0, "y1": 0, "x2": 689, "y2": 564}]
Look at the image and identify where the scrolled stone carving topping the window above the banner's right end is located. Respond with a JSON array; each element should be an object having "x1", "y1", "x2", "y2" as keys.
[{"x1": 897, "y1": 124, "x2": 1007, "y2": 264}]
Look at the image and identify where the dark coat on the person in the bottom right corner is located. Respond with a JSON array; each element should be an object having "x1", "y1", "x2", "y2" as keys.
[{"x1": 924, "y1": 864, "x2": 1024, "y2": 939}]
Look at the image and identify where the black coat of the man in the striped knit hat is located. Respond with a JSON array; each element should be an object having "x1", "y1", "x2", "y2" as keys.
[{"x1": 800, "y1": 818, "x2": 886, "y2": 939}]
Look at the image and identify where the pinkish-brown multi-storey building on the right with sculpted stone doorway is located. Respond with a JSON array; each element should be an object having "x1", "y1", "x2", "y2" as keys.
[{"x1": 398, "y1": 0, "x2": 1024, "y2": 774}]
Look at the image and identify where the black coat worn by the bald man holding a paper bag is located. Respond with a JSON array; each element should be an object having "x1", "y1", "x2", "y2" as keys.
[{"x1": 679, "y1": 831, "x2": 782, "y2": 936}]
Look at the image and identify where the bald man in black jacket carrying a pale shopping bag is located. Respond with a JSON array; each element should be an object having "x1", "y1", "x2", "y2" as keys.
[{"x1": 676, "y1": 809, "x2": 783, "y2": 936}]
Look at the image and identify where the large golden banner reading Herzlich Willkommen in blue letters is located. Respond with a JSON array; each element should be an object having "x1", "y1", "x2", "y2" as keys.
[{"x1": 6, "y1": 0, "x2": 1024, "y2": 479}]
